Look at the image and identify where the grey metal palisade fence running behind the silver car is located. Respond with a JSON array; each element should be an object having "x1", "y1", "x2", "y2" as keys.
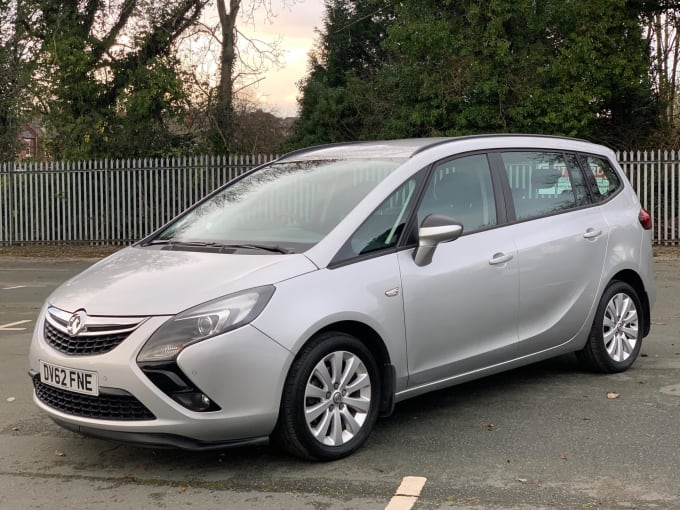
[{"x1": 0, "y1": 150, "x2": 680, "y2": 244}]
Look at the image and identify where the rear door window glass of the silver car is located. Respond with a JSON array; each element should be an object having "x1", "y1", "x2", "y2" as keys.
[{"x1": 501, "y1": 152, "x2": 588, "y2": 220}]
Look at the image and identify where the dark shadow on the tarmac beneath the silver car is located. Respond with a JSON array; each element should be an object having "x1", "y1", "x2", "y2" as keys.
[{"x1": 71, "y1": 354, "x2": 602, "y2": 466}]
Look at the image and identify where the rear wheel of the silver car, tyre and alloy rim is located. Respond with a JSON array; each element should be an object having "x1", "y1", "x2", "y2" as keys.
[{"x1": 576, "y1": 281, "x2": 645, "y2": 373}]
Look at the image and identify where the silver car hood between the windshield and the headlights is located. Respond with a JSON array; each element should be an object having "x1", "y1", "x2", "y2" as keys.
[{"x1": 48, "y1": 247, "x2": 317, "y2": 316}]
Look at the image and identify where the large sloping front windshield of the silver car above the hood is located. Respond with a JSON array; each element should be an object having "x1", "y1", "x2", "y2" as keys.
[{"x1": 147, "y1": 159, "x2": 401, "y2": 253}]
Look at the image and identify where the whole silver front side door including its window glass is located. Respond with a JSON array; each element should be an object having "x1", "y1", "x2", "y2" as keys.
[{"x1": 399, "y1": 154, "x2": 518, "y2": 388}]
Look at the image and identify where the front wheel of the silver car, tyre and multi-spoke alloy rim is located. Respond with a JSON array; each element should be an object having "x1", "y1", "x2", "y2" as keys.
[{"x1": 272, "y1": 332, "x2": 381, "y2": 460}]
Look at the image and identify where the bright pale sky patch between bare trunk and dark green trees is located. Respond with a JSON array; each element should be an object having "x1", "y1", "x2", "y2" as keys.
[{"x1": 239, "y1": 0, "x2": 324, "y2": 117}]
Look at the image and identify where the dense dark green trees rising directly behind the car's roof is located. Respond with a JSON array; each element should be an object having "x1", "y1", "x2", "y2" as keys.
[{"x1": 295, "y1": 0, "x2": 658, "y2": 146}]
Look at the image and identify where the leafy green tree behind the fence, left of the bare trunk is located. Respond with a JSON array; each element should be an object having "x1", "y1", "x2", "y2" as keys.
[{"x1": 26, "y1": 0, "x2": 205, "y2": 160}]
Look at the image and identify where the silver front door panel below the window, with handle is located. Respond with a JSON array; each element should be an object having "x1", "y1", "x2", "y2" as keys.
[{"x1": 399, "y1": 228, "x2": 518, "y2": 387}]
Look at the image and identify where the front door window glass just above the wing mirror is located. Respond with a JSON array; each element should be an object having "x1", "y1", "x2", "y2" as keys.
[{"x1": 418, "y1": 154, "x2": 497, "y2": 232}]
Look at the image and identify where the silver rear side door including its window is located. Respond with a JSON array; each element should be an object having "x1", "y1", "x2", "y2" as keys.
[{"x1": 495, "y1": 151, "x2": 609, "y2": 355}]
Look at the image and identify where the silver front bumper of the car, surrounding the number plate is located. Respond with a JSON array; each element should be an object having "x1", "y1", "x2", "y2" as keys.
[{"x1": 29, "y1": 311, "x2": 293, "y2": 449}]
